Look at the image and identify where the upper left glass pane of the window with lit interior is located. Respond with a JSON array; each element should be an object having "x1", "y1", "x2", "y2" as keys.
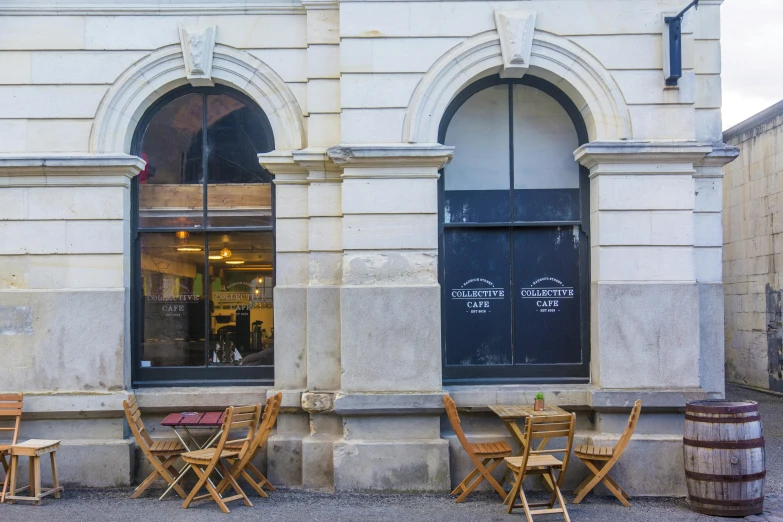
[{"x1": 138, "y1": 94, "x2": 204, "y2": 228}]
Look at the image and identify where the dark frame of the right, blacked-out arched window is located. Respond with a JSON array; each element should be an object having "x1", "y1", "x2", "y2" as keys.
[{"x1": 438, "y1": 75, "x2": 590, "y2": 385}]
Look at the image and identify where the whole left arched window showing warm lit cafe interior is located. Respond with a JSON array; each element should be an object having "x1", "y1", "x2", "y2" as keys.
[{"x1": 131, "y1": 86, "x2": 275, "y2": 386}]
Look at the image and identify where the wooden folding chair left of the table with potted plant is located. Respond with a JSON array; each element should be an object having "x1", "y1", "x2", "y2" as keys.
[{"x1": 443, "y1": 395, "x2": 511, "y2": 502}]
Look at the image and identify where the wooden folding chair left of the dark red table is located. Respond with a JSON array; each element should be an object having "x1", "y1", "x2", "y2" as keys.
[{"x1": 122, "y1": 395, "x2": 185, "y2": 498}]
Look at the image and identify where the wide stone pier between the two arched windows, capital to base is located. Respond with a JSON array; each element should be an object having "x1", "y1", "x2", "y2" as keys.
[{"x1": 329, "y1": 144, "x2": 452, "y2": 491}]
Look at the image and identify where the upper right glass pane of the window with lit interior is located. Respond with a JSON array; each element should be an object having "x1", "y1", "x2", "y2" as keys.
[{"x1": 207, "y1": 94, "x2": 274, "y2": 227}]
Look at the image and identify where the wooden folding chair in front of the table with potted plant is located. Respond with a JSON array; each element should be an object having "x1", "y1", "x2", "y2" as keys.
[{"x1": 505, "y1": 413, "x2": 576, "y2": 522}]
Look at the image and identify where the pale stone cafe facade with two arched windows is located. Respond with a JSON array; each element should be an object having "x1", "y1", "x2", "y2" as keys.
[{"x1": 0, "y1": 0, "x2": 736, "y2": 495}]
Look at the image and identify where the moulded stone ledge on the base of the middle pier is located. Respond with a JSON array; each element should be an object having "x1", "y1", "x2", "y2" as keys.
[{"x1": 334, "y1": 393, "x2": 445, "y2": 415}]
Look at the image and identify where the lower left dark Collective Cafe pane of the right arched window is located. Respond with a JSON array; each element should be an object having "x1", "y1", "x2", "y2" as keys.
[{"x1": 443, "y1": 229, "x2": 512, "y2": 366}]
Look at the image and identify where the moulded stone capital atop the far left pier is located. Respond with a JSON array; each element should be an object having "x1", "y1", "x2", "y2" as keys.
[{"x1": 0, "y1": 154, "x2": 145, "y2": 187}]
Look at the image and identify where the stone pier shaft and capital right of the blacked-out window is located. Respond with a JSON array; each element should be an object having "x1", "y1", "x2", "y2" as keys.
[{"x1": 574, "y1": 141, "x2": 712, "y2": 389}]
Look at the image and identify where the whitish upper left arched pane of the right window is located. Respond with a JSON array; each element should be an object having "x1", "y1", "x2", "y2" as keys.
[{"x1": 444, "y1": 85, "x2": 510, "y2": 190}]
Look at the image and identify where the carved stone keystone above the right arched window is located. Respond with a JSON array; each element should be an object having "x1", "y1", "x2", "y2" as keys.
[{"x1": 495, "y1": 11, "x2": 536, "y2": 78}]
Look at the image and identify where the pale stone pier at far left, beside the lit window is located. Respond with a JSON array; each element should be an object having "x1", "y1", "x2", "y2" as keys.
[{"x1": 0, "y1": 154, "x2": 144, "y2": 486}]
